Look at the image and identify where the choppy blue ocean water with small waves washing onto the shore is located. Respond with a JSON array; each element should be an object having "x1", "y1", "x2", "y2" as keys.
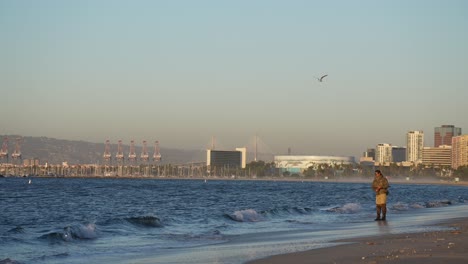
[{"x1": 0, "y1": 178, "x2": 468, "y2": 264}]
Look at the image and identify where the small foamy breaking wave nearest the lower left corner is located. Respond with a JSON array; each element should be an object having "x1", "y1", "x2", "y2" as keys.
[{"x1": 40, "y1": 223, "x2": 98, "y2": 243}]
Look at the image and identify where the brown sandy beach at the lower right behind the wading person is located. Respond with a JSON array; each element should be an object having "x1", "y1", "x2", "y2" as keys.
[{"x1": 248, "y1": 218, "x2": 468, "y2": 264}]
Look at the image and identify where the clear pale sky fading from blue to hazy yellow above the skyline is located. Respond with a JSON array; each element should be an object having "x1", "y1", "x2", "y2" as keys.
[{"x1": 0, "y1": 0, "x2": 468, "y2": 157}]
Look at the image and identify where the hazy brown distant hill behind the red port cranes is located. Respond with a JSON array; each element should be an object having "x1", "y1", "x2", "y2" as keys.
[{"x1": 0, "y1": 135, "x2": 273, "y2": 164}]
